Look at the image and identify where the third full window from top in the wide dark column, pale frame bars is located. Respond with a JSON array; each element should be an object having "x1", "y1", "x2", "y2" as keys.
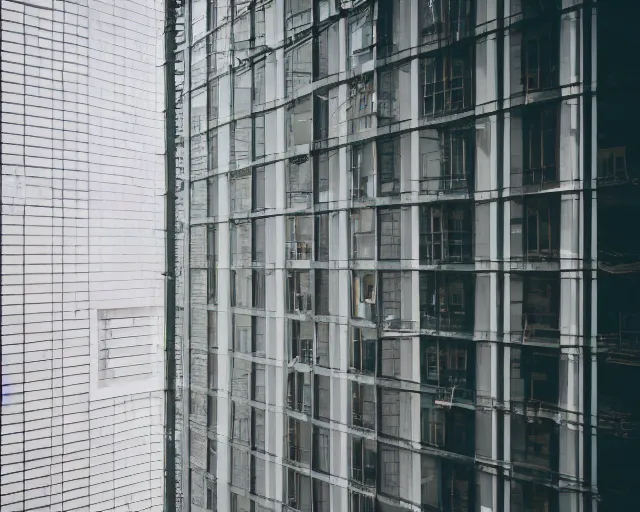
[{"x1": 420, "y1": 203, "x2": 473, "y2": 265}]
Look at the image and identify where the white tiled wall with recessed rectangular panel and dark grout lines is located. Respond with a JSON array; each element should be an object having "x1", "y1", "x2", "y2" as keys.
[{"x1": 0, "y1": 0, "x2": 164, "y2": 512}]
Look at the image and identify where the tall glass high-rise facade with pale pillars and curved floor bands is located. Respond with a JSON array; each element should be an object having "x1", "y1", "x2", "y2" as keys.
[{"x1": 169, "y1": 0, "x2": 640, "y2": 512}]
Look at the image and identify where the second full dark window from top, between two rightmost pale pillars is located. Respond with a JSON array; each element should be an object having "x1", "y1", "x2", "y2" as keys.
[{"x1": 523, "y1": 106, "x2": 558, "y2": 186}]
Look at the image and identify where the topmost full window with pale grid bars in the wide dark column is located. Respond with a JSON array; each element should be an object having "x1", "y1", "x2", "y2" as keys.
[{"x1": 421, "y1": 46, "x2": 473, "y2": 116}]
